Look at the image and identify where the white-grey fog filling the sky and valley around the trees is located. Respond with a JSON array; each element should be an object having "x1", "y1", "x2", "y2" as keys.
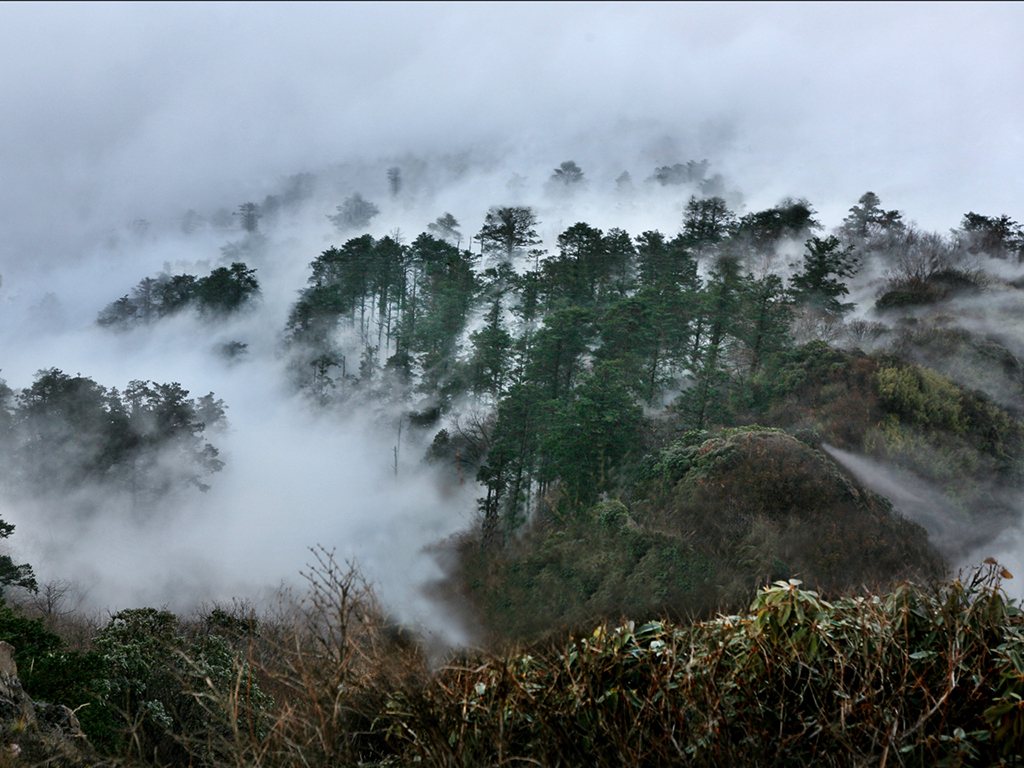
[{"x1": 0, "y1": 3, "x2": 1024, "y2": 624}]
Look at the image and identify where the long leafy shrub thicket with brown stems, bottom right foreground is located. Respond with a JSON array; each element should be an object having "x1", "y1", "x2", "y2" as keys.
[{"x1": 380, "y1": 564, "x2": 1024, "y2": 766}]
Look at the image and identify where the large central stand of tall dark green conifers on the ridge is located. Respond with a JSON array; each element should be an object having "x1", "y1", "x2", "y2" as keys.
[{"x1": 288, "y1": 192, "x2": 1022, "y2": 538}]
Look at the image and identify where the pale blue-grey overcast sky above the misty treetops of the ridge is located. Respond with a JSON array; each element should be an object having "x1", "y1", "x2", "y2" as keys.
[{"x1": 0, "y1": 2, "x2": 1024, "y2": 269}]
